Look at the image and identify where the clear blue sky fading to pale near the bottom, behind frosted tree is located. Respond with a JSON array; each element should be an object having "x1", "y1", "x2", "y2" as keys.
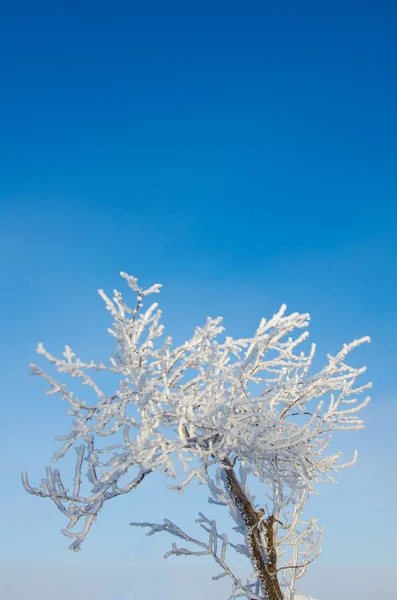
[{"x1": 0, "y1": 0, "x2": 397, "y2": 600}]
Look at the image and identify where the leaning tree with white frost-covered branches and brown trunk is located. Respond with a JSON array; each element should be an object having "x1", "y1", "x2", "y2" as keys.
[{"x1": 22, "y1": 273, "x2": 370, "y2": 600}]
